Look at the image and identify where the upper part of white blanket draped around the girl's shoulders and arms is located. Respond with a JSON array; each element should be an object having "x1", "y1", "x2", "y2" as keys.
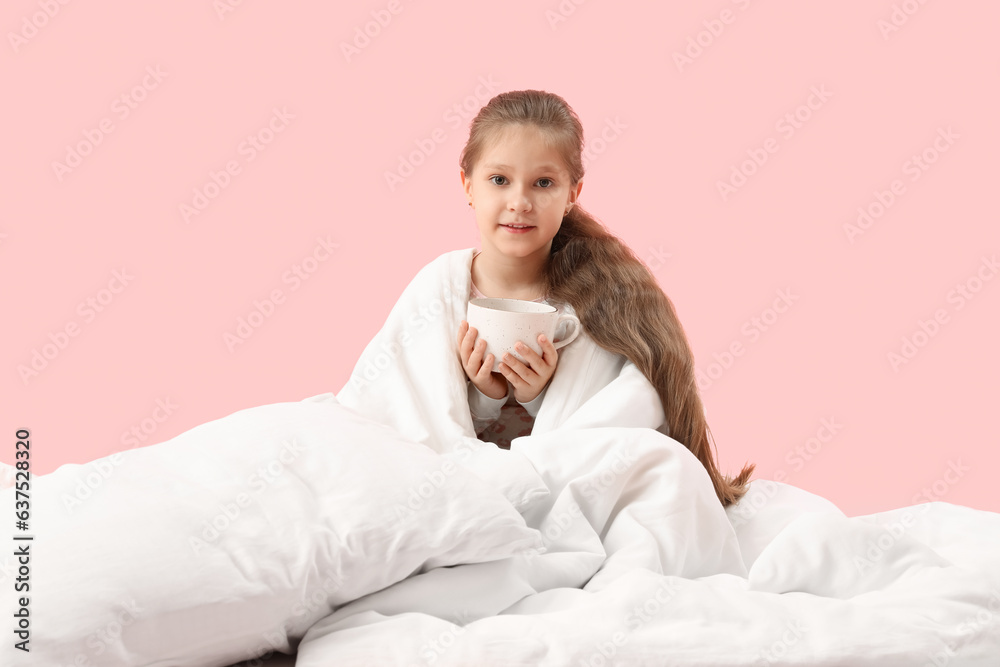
[{"x1": 337, "y1": 248, "x2": 668, "y2": 453}]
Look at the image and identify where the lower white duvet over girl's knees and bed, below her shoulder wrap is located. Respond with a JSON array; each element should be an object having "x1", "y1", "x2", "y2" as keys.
[{"x1": 296, "y1": 429, "x2": 1000, "y2": 667}]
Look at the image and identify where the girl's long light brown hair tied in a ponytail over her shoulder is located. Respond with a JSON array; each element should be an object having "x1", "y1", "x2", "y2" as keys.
[{"x1": 459, "y1": 90, "x2": 755, "y2": 507}]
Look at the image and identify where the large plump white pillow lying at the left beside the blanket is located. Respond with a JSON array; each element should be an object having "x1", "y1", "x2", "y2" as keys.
[{"x1": 7, "y1": 393, "x2": 542, "y2": 667}]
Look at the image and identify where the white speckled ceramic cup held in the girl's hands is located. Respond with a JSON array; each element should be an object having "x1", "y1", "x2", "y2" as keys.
[{"x1": 466, "y1": 298, "x2": 580, "y2": 373}]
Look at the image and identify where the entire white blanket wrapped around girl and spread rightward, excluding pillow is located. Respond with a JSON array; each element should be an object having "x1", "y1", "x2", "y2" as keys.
[{"x1": 296, "y1": 249, "x2": 1000, "y2": 667}]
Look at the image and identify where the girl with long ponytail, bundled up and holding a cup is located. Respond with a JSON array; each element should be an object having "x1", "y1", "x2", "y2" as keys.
[{"x1": 457, "y1": 90, "x2": 754, "y2": 506}]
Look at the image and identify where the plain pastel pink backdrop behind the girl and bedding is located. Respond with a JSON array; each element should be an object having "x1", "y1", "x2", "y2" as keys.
[{"x1": 0, "y1": 0, "x2": 1000, "y2": 515}]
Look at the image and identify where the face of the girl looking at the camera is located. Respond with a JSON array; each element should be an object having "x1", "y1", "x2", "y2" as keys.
[{"x1": 462, "y1": 125, "x2": 583, "y2": 264}]
